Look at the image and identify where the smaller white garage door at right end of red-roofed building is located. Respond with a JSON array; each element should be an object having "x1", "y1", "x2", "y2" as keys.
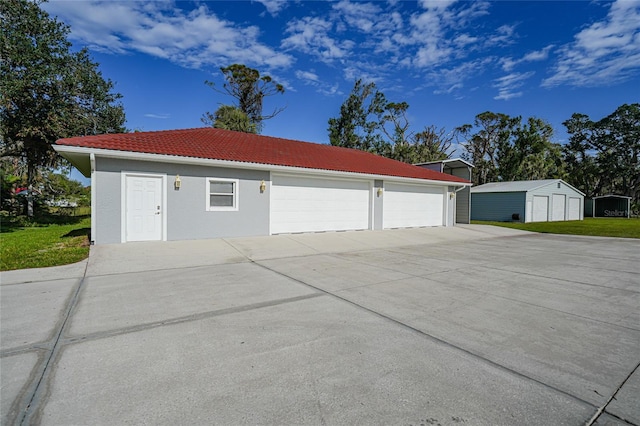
[{"x1": 382, "y1": 183, "x2": 445, "y2": 228}]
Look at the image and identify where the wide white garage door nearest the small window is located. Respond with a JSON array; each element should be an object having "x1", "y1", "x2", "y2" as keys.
[{"x1": 271, "y1": 175, "x2": 371, "y2": 234}]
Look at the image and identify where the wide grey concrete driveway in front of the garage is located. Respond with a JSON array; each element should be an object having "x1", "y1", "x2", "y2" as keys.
[{"x1": 0, "y1": 225, "x2": 640, "y2": 425}]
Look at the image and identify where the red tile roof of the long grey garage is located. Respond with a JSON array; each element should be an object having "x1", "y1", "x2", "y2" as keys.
[{"x1": 56, "y1": 127, "x2": 468, "y2": 183}]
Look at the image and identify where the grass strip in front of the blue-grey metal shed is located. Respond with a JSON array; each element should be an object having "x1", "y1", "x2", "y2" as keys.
[{"x1": 471, "y1": 217, "x2": 640, "y2": 238}]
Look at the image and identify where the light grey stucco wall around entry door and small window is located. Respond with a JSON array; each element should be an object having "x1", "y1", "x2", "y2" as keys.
[{"x1": 93, "y1": 157, "x2": 269, "y2": 244}]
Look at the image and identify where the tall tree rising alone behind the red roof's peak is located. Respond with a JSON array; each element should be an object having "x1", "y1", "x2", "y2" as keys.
[{"x1": 205, "y1": 64, "x2": 285, "y2": 132}]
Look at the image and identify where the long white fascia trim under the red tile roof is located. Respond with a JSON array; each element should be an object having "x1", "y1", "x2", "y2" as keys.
[{"x1": 54, "y1": 145, "x2": 472, "y2": 186}]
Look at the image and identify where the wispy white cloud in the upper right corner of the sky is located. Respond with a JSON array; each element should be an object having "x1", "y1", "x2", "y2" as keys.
[{"x1": 542, "y1": 0, "x2": 640, "y2": 87}]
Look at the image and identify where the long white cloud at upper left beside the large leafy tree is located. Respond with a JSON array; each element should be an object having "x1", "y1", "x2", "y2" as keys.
[{"x1": 43, "y1": 1, "x2": 294, "y2": 68}]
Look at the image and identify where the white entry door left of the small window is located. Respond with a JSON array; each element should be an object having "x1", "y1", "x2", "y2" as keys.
[{"x1": 124, "y1": 175, "x2": 164, "y2": 241}]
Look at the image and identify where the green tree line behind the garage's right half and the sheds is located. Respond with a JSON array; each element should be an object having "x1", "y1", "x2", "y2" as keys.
[{"x1": 327, "y1": 80, "x2": 640, "y2": 210}]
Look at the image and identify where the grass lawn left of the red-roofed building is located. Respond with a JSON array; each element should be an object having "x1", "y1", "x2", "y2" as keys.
[{"x1": 0, "y1": 217, "x2": 91, "y2": 271}]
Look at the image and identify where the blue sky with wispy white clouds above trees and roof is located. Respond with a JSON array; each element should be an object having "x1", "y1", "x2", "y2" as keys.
[{"x1": 43, "y1": 0, "x2": 640, "y2": 171}]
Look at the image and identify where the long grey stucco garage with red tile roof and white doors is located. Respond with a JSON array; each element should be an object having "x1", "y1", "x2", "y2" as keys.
[{"x1": 55, "y1": 128, "x2": 471, "y2": 244}]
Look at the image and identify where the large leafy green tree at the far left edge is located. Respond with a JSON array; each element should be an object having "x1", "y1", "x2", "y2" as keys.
[{"x1": 0, "y1": 0, "x2": 125, "y2": 215}]
